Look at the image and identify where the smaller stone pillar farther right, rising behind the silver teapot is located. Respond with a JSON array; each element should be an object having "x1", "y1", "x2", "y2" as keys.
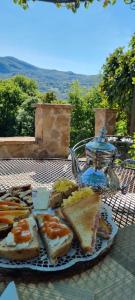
[{"x1": 94, "y1": 108, "x2": 117, "y2": 136}]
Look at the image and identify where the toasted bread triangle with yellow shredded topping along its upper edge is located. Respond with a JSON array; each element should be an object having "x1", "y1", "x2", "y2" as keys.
[{"x1": 62, "y1": 188, "x2": 100, "y2": 252}]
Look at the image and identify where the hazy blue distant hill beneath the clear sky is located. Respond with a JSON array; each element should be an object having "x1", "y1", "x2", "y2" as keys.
[{"x1": 0, "y1": 56, "x2": 99, "y2": 98}]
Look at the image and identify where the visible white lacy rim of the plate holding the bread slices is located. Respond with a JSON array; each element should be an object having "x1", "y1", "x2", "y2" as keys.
[{"x1": 0, "y1": 204, "x2": 118, "y2": 272}]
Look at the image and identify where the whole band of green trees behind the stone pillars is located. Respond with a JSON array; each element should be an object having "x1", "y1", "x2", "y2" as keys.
[{"x1": 0, "y1": 34, "x2": 135, "y2": 145}]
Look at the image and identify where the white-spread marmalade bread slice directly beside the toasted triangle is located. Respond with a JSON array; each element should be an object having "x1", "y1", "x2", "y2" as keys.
[{"x1": 36, "y1": 215, "x2": 73, "y2": 263}]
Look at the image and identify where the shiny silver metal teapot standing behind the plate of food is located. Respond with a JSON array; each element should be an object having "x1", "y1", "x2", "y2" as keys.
[{"x1": 70, "y1": 128, "x2": 134, "y2": 193}]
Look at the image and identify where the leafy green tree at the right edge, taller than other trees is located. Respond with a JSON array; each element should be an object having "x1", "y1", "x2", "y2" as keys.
[{"x1": 100, "y1": 34, "x2": 135, "y2": 132}]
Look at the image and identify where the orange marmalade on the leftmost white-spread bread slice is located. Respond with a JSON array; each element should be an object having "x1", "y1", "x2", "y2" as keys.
[{"x1": 11, "y1": 220, "x2": 31, "y2": 244}]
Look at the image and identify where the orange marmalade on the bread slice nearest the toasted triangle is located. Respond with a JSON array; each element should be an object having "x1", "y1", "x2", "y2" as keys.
[{"x1": 42, "y1": 214, "x2": 70, "y2": 239}]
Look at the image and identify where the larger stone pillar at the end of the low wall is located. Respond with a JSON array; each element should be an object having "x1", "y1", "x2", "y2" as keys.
[{"x1": 33, "y1": 104, "x2": 72, "y2": 157}]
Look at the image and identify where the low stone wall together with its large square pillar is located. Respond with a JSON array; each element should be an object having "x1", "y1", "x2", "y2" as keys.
[{"x1": 0, "y1": 104, "x2": 72, "y2": 159}]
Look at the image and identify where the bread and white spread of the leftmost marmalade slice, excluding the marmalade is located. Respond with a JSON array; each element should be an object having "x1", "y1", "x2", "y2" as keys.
[{"x1": 0, "y1": 217, "x2": 39, "y2": 260}]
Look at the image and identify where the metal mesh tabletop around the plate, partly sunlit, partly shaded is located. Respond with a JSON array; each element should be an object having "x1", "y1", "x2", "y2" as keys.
[{"x1": 0, "y1": 159, "x2": 135, "y2": 300}]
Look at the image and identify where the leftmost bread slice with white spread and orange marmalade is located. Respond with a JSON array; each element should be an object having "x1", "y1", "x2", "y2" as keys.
[{"x1": 0, "y1": 216, "x2": 39, "y2": 260}]
